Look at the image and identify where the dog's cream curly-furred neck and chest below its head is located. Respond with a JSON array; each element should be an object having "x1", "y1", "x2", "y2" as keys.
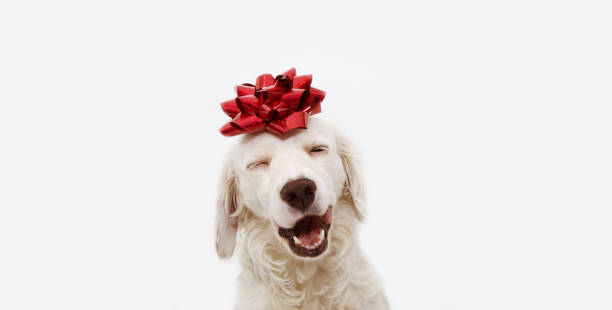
[{"x1": 232, "y1": 201, "x2": 387, "y2": 310}]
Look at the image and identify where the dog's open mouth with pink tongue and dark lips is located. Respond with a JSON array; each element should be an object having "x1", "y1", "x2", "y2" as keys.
[{"x1": 278, "y1": 207, "x2": 332, "y2": 257}]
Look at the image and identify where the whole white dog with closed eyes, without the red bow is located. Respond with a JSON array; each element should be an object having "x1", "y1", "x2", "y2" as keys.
[{"x1": 216, "y1": 118, "x2": 389, "y2": 310}]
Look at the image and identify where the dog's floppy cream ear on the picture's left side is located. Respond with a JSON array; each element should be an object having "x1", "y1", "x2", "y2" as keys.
[{"x1": 216, "y1": 162, "x2": 240, "y2": 258}]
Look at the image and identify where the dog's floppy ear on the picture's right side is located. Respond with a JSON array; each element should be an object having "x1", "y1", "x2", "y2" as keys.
[{"x1": 336, "y1": 133, "x2": 366, "y2": 220}]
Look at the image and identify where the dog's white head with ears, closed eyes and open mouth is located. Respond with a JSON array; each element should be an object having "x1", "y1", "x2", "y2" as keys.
[{"x1": 217, "y1": 119, "x2": 364, "y2": 258}]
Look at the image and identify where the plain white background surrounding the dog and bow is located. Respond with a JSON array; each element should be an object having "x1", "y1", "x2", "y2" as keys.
[{"x1": 0, "y1": 0, "x2": 612, "y2": 310}]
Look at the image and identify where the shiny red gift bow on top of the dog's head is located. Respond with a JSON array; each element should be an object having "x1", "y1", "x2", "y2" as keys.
[{"x1": 220, "y1": 68, "x2": 325, "y2": 136}]
